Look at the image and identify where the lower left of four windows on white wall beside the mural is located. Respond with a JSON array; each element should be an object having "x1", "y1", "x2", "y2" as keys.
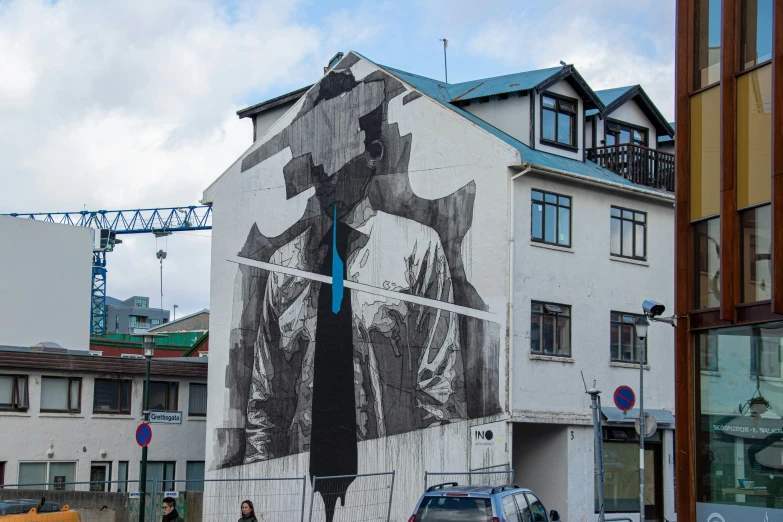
[{"x1": 530, "y1": 301, "x2": 571, "y2": 357}]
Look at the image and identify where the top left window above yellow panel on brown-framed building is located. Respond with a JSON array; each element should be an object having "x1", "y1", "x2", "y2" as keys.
[{"x1": 693, "y1": 0, "x2": 722, "y2": 90}]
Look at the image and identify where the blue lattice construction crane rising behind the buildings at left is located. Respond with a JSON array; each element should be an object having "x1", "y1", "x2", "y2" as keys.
[{"x1": 0, "y1": 206, "x2": 212, "y2": 335}]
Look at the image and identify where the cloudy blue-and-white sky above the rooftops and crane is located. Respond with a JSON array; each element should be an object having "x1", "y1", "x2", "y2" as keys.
[{"x1": 0, "y1": 0, "x2": 674, "y2": 316}]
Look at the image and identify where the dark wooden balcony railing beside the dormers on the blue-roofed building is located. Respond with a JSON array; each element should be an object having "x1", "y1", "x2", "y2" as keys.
[{"x1": 587, "y1": 143, "x2": 674, "y2": 192}]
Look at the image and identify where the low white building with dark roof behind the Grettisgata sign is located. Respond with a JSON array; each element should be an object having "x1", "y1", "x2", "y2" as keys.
[{"x1": 0, "y1": 346, "x2": 207, "y2": 491}]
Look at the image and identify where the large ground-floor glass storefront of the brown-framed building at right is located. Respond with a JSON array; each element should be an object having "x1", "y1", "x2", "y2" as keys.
[{"x1": 694, "y1": 322, "x2": 783, "y2": 508}]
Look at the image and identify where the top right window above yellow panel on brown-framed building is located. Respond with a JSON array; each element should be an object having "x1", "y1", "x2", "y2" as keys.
[{"x1": 739, "y1": 0, "x2": 773, "y2": 71}]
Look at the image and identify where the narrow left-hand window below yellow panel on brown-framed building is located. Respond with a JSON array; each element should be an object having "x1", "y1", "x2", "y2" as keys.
[{"x1": 693, "y1": 218, "x2": 720, "y2": 309}]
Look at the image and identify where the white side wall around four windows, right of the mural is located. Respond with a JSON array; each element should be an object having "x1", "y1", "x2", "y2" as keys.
[{"x1": 511, "y1": 174, "x2": 674, "y2": 414}]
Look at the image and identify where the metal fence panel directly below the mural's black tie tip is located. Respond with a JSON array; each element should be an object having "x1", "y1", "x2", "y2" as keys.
[{"x1": 309, "y1": 471, "x2": 394, "y2": 522}]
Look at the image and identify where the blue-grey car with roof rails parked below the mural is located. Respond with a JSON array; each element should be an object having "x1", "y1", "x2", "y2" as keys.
[{"x1": 408, "y1": 482, "x2": 560, "y2": 522}]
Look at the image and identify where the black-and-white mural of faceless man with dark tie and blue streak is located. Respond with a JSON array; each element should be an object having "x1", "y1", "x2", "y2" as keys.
[{"x1": 216, "y1": 54, "x2": 500, "y2": 519}]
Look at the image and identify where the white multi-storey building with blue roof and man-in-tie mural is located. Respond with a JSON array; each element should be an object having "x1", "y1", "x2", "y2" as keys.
[{"x1": 203, "y1": 52, "x2": 676, "y2": 521}]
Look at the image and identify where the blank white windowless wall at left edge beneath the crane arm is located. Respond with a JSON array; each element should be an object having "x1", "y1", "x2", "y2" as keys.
[{"x1": 0, "y1": 216, "x2": 92, "y2": 350}]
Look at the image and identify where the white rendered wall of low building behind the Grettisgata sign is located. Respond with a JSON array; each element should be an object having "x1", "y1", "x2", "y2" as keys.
[{"x1": 0, "y1": 369, "x2": 206, "y2": 484}]
